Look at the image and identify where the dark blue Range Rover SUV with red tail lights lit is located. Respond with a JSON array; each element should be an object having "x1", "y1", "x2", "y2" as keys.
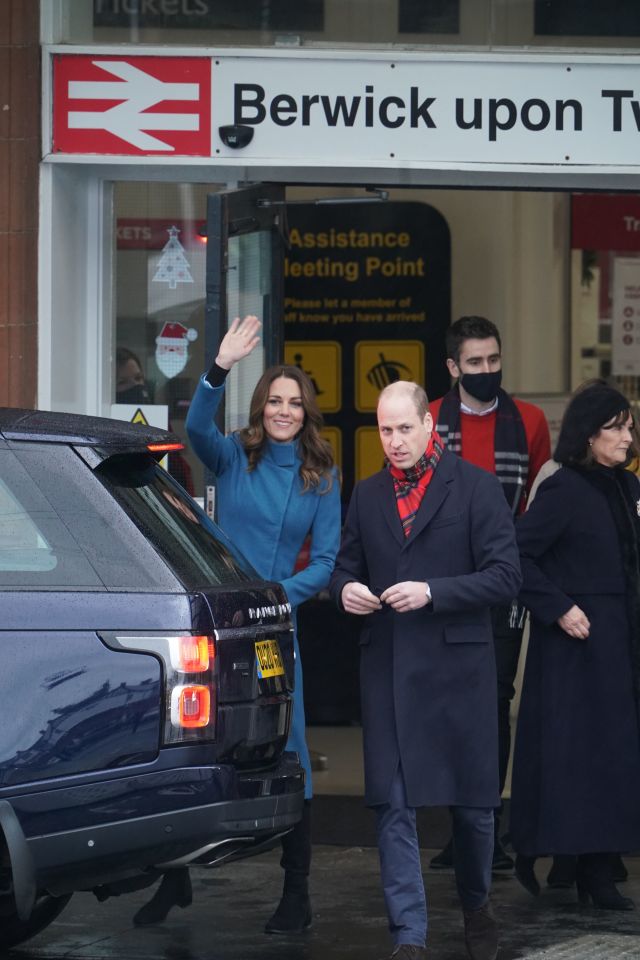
[{"x1": 0, "y1": 409, "x2": 304, "y2": 946}]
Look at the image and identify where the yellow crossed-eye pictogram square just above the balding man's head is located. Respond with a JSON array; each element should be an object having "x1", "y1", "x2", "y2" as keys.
[{"x1": 355, "y1": 340, "x2": 424, "y2": 413}]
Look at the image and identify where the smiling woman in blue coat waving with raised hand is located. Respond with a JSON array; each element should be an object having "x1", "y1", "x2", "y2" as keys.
[{"x1": 134, "y1": 316, "x2": 341, "y2": 933}]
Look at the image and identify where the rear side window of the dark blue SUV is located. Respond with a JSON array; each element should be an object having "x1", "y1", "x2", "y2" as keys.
[{"x1": 0, "y1": 442, "x2": 175, "y2": 592}]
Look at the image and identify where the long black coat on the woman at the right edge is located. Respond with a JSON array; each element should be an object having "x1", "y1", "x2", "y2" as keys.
[{"x1": 511, "y1": 468, "x2": 640, "y2": 854}]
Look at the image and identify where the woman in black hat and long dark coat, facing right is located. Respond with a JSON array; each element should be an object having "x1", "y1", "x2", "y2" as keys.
[{"x1": 511, "y1": 383, "x2": 640, "y2": 910}]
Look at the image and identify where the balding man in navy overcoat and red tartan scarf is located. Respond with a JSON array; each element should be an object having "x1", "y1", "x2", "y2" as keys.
[{"x1": 330, "y1": 381, "x2": 521, "y2": 960}]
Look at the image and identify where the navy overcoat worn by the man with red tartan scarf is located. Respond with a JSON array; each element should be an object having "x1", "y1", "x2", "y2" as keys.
[{"x1": 330, "y1": 451, "x2": 520, "y2": 807}]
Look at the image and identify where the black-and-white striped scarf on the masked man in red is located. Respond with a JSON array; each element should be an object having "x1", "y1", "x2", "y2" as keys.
[{"x1": 436, "y1": 387, "x2": 529, "y2": 516}]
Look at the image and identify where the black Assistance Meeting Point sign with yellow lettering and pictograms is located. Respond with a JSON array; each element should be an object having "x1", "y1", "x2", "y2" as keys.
[{"x1": 284, "y1": 202, "x2": 451, "y2": 499}]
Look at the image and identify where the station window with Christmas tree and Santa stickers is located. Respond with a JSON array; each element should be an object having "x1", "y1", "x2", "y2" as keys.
[{"x1": 111, "y1": 183, "x2": 212, "y2": 493}]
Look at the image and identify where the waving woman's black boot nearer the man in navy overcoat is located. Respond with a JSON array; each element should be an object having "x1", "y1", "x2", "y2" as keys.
[{"x1": 264, "y1": 800, "x2": 311, "y2": 933}]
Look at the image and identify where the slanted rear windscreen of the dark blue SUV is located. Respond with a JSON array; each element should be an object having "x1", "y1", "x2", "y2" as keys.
[{"x1": 96, "y1": 454, "x2": 255, "y2": 590}]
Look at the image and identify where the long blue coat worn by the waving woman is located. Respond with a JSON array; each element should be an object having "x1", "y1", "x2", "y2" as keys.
[{"x1": 186, "y1": 377, "x2": 340, "y2": 797}]
